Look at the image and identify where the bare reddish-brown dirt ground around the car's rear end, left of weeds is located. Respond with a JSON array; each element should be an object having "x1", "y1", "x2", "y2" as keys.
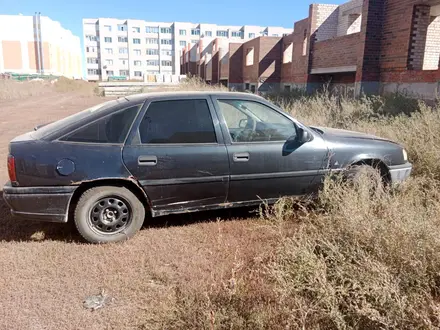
[{"x1": 0, "y1": 92, "x2": 268, "y2": 330}]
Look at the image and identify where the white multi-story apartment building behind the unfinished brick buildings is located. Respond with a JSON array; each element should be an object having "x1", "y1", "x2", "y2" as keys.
[{"x1": 83, "y1": 18, "x2": 292, "y2": 80}]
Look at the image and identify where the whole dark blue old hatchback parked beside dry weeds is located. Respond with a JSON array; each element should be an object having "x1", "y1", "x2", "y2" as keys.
[{"x1": 4, "y1": 92, "x2": 412, "y2": 243}]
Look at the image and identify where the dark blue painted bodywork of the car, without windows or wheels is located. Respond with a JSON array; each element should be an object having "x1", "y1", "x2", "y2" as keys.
[{"x1": 4, "y1": 92, "x2": 412, "y2": 222}]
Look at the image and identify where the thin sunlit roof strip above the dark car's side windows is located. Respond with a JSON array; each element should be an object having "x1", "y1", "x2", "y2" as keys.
[{"x1": 125, "y1": 91, "x2": 264, "y2": 101}]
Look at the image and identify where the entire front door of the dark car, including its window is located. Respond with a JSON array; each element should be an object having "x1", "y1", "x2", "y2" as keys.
[{"x1": 213, "y1": 97, "x2": 328, "y2": 203}]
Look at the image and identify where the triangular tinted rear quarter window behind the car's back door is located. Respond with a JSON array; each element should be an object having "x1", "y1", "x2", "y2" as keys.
[{"x1": 61, "y1": 105, "x2": 140, "y2": 143}]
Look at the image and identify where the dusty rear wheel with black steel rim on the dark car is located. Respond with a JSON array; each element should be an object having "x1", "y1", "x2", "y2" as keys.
[{"x1": 74, "y1": 186, "x2": 145, "y2": 244}]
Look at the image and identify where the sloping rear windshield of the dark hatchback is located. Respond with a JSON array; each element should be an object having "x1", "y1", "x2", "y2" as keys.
[{"x1": 31, "y1": 100, "x2": 120, "y2": 139}]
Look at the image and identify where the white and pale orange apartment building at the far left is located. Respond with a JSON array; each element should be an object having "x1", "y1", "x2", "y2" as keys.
[{"x1": 0, "y1": 14, "x2": 83, "y2": 78}]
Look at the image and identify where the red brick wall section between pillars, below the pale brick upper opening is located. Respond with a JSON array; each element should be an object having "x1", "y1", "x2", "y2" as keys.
[{"x1": 311, "y1": 33, "x2": 360, "y2": 69}]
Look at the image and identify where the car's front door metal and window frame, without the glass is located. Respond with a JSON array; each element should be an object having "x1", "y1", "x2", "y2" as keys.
[{"x1": 213, "y1": 95, "x2": 328, "y2": 203}]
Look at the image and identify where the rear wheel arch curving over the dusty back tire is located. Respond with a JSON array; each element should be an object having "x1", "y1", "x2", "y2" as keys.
[{"x1": 66, "y1": 178, "x2": 151, "y2": 222}]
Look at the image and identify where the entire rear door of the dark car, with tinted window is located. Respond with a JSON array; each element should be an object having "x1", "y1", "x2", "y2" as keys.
[{"x1": 123, "y1": 97, "x2": 229, "y2": 214}]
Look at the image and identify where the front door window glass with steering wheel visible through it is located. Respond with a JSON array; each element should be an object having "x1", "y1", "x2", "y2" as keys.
[{"x1": 218, "y1": 99, "x2": 296, "y2": 143}]
